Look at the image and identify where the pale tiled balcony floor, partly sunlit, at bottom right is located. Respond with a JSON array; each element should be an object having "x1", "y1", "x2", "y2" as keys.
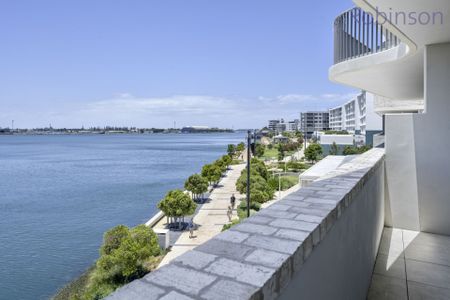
[{"x1": 368, "y1": 228, "x2": 450, "y2": 300}]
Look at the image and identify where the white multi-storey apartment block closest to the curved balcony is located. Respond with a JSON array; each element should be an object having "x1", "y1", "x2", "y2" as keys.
[{"x1": 329, "y1": 91, "x2": 383, "y2": 145}]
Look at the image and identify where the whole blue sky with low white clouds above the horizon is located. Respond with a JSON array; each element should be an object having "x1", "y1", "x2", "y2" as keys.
[{"x1": 0, "y1": 0, "x2": 356, "y2": 128}]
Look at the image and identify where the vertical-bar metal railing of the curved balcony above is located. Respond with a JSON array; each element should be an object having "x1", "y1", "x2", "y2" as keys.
[{"x1": 334, "y1": 7, "x2": 400, "y2": 64}]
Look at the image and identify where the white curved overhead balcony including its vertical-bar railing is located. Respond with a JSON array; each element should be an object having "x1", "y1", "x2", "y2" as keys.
[{"x1": 329, "y1": 8, "x2": 424, "y2": 100}]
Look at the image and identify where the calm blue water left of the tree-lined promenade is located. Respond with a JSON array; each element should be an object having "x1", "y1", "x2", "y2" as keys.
[{"x1": 0, "y1": 134, "x2": 243, "y2": 299}]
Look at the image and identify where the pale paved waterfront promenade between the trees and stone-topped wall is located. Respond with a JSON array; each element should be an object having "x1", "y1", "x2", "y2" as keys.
[{"x1": 157, "y1": 164, "x2": 245, "y2": 267}]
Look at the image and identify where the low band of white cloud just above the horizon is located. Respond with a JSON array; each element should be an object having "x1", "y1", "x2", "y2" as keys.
[{"x1": 0, "y1": 93, "x2": 354, "y2": 128}]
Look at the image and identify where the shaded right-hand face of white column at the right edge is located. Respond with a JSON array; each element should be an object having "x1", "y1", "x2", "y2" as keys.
[{"x1": 414, "y1": 43, "x2": 450, "y2": 235}]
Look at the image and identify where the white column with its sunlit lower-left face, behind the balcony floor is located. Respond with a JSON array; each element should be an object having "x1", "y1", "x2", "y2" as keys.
[{"x1": 385, "y1": 43, "x2": 450, "y2": 235}]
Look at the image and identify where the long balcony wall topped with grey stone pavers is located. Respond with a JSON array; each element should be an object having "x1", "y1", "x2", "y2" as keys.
[{"x1": 109, "y1": 149, "x2": 385, "y2": 300}]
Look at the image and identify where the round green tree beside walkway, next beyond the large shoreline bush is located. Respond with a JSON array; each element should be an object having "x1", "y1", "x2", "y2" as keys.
[{"x1": 158, "y1": 190, "x2": 197, "y2": 226}]
